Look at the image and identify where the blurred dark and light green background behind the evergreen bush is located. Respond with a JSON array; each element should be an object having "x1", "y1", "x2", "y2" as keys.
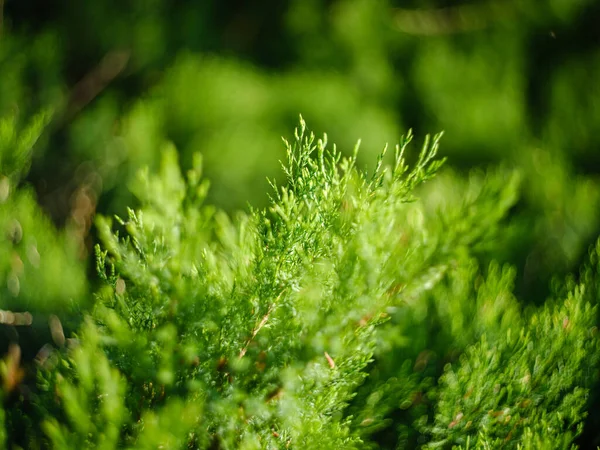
[{"x1": 0, "y1": 0, "x2": 600, "y2": 302}]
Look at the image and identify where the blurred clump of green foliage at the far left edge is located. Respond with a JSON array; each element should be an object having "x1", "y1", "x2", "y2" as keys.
[{"x1": 0, "y1": 114, "x2": 87, "y2": 312}]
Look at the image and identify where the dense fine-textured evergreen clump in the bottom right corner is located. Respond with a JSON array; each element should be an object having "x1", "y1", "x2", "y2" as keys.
[{"x1": 430, "y1": 276, "x2": 598, "y2": 448}]
